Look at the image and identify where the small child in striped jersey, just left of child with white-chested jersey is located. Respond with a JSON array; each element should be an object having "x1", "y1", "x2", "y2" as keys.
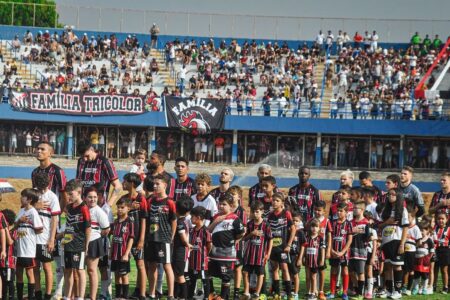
[{"x1": 188, "y1": 206, "x2": 212, "y2": 299}]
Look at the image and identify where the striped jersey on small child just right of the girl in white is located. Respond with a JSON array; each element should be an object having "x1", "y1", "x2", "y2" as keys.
[{"x1": 111, "y1": 217, "x2": 135, "y2": 260}]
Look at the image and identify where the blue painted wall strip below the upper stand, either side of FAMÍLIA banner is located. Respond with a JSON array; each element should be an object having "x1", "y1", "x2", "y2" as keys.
[{"x1": 0, "y1": 104, "x2": 450, "y2": 137}]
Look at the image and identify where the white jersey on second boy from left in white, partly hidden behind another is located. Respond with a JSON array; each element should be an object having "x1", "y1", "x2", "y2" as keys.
[{"x1": 36, "y1": 190, "x2": 61, "y2": 245}]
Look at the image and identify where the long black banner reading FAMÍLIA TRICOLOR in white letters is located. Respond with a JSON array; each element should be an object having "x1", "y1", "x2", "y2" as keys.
[{"x1": 9, "y1": 90, "x2": 146, "y2": 115}]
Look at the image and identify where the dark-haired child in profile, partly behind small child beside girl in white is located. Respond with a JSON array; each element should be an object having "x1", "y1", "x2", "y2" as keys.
[{"x1": 122, "y1": 173, "x2": 148, "y2": 297}]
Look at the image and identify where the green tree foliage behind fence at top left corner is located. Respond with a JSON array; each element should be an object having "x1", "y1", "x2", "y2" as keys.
[{"x1": 0, "y1": 0, "x2": 61, "y2": 27}]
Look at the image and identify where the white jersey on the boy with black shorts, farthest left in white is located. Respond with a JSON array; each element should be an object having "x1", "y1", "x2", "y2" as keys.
[{"x1": 16, "y1": 207, "x2": 44, "y2": 258}]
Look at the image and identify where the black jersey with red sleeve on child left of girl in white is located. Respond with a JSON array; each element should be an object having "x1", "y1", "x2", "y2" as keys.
[{"x1": 63, "y1": 202, "x2": 91, "y2": 252}]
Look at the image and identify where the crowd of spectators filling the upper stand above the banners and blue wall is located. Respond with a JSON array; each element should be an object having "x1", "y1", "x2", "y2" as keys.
[{"x1": 0, "y1": 24, "x2": 444, "y2": 119}]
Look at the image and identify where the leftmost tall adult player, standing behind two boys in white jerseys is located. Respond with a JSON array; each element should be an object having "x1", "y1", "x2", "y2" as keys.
[{"x1": 31, "y1": 142, "x2": 67, "y2": 209}]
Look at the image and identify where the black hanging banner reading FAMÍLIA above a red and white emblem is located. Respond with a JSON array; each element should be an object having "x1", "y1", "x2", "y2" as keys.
[{"x1": 165, "y1": 96, "x2": 225, "y2": 135}]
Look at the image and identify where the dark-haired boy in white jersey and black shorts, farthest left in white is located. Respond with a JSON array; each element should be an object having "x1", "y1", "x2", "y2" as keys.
[{"x1": 15, "y1": 188, "x2": 44, "y2": 300}]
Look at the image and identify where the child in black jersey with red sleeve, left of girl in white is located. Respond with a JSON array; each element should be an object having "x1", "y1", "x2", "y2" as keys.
[{"x1": 62, "y1": 179, "x2": 91, "y2": 300}]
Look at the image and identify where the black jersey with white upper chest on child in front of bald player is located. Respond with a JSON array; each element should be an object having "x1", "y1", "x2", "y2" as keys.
[{"x1": 209, "y1": 213, "x2": 244, "y2": 261}]
